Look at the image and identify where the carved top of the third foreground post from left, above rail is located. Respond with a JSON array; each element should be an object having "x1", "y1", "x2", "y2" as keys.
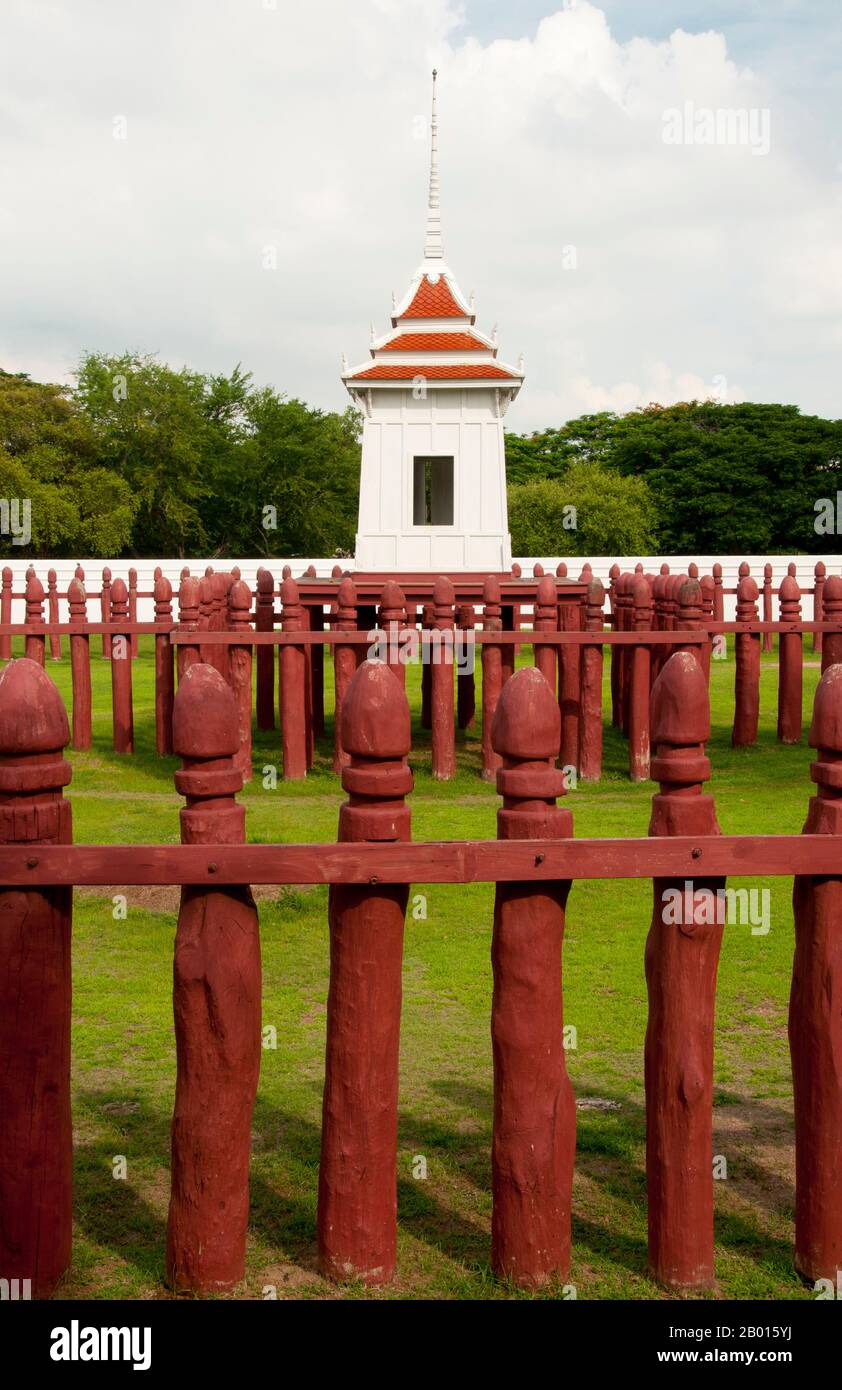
[{"x1": 339, "y1": 662, "x2": 413, "y2": 840}]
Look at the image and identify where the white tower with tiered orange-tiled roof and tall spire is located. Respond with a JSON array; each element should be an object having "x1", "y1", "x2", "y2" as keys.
[{"x1": 342, "y1": 71, "x2": 524, "y2": 573}]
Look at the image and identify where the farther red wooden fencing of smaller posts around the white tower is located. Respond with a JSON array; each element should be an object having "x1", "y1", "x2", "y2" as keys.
[{"x1": 0, "y1": 562, "x2": 842, "y2": 781}]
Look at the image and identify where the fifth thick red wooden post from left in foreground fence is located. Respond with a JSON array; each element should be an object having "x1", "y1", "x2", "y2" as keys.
[{"x1": 645, "y1": 652, "x2": 724, "y2": 1289}]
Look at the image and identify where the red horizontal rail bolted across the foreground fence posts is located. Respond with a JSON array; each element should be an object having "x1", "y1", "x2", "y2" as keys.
[{"x1": 0, "y1": 835, "x2": 842, "y2": 887}]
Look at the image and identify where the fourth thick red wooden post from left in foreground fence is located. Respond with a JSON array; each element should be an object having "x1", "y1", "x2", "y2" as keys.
[{"x1": 492, "y1": 669, "x2": 575, "y2": 1287}]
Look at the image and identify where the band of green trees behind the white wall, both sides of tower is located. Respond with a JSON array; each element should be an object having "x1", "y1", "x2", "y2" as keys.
[{"x1": 0, "y1": 352, "x2": 842, "y2": 559}]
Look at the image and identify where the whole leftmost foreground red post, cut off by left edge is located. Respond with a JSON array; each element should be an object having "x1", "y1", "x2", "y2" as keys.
[{"x1": 0, "y1": 660, "x2": 72, "y2": 1298}]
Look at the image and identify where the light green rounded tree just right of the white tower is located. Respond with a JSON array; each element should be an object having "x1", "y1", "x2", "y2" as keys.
[{"x1": 509, "y1": 463, "x2": 656, "y2": 556}]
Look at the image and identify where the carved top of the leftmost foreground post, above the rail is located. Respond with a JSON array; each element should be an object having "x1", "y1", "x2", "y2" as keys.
[{"x1": 0, "y1": 657, "x2": 72, "y2": 844}]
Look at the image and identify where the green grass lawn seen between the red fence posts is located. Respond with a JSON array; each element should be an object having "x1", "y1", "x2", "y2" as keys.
[{"x1": 6, "y1": 639, "x2": 818, "y2": 1298}]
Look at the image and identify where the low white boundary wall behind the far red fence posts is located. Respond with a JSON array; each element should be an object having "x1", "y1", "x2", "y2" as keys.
[{"x1": 3, "y1": 555, "x2": 842, "y2": 623}]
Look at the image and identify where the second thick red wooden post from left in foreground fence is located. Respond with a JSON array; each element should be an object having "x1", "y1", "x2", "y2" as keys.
[{"x1": 167, "y1": 663, "x2": 260, "y2": 1293}]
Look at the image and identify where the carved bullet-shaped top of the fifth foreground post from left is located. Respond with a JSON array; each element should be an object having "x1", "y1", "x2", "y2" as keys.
[{"x1": 650, "y1": 652, "x2": 710, "y2": 791}]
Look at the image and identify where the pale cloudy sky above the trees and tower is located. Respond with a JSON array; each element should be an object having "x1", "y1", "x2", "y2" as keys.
[{"x1": 0, "y1": 0, "x2": 842, "y2": 431}]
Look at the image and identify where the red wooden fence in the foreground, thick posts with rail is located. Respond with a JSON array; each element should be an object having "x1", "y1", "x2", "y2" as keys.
[{"x1": 0, "y1": 648, "x2": 842, "y2": 1295}]
